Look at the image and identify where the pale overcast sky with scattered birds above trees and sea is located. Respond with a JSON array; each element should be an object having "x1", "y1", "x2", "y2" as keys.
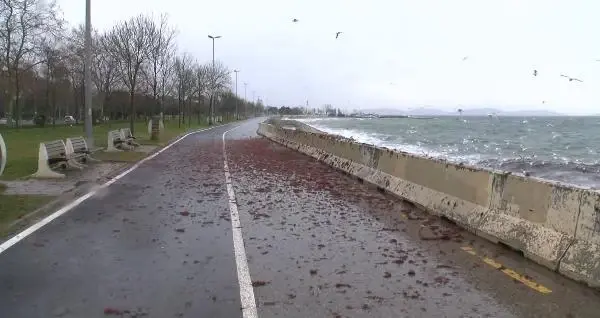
[{"x1": 58, "y1": 0, "x2": 600, "y2": 115}]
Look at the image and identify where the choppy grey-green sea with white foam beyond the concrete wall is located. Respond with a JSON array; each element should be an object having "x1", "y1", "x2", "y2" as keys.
[{"x1": 300, "y1": 116, "x2": 600, "y2": 189}]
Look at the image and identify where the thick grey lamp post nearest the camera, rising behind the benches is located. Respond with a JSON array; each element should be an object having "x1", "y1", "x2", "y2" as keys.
[{"x1": 83, "y1": 0, "x2": 93, "y2": 148}]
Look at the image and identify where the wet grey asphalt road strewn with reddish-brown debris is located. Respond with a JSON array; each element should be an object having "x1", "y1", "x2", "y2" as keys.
[{"x1": 0, "y1": 120, "x2": 600, "y2": 318}]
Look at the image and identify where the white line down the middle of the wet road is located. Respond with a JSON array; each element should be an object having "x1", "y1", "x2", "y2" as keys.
[{"x1": 223, "y1": 126, "x2": 258, "y2": 318}]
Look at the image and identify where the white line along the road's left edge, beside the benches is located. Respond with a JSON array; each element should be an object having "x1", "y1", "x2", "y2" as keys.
[{"x1": 0, "y1": 125, "x2": 222, "y2": 254}]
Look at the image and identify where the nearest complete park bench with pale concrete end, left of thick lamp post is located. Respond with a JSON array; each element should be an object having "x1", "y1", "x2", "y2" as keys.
[{"x1": 33, "y1": 140, "x2": 69, "y2": 178}]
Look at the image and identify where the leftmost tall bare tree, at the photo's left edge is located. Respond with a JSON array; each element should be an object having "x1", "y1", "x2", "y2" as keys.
[{"x1": 0, "y1": 0, "x2": 62, "y2": 127}]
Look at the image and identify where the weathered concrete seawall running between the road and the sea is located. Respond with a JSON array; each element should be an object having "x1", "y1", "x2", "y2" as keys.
[{"x1": 258, "y1": 120, "x2": 600, "y2": 287}]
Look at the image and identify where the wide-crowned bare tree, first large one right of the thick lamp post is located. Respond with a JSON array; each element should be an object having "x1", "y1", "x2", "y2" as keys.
[{"x1": 107, "y1": 15, "x2": 153, "y2": 133}]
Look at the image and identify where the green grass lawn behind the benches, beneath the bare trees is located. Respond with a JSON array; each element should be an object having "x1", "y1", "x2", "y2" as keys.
[{"x1": 0, "y1": 120, "x2": 212, "y2": 180}]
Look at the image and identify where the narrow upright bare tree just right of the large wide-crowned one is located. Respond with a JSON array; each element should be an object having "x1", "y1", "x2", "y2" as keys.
[{"x1": 146, "y1": 15, "x2": 175, "y2": 117}]
